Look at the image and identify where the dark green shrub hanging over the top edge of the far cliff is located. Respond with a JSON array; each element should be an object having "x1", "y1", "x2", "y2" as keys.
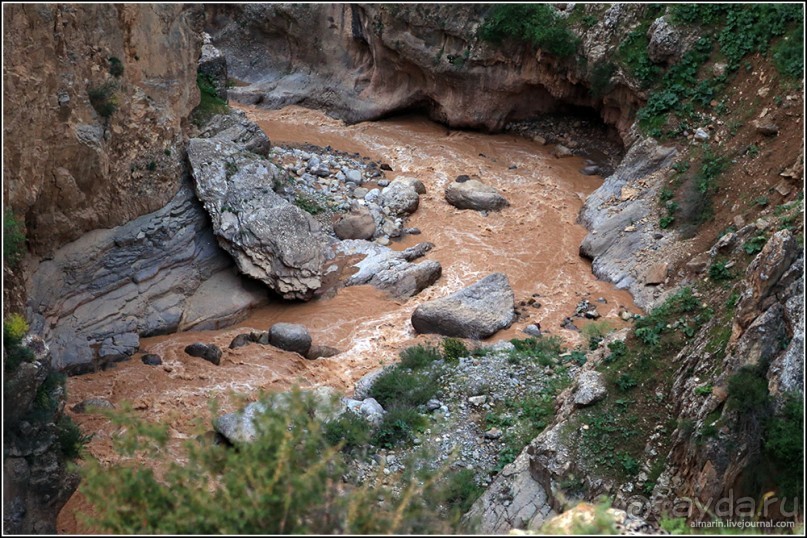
[{"x1": 479, "y1": 4, "x2": 579, "y2": 58}]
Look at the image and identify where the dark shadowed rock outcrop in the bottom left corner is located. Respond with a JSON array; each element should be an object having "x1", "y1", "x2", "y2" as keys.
[{"x1": 3, "y1": 337, "x2": 79, "y2": 534}]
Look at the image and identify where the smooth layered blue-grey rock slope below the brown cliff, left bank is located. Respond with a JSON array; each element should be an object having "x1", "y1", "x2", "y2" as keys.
[{"x1": 27, "y1": 185, "x2": 266, "y2": 373}]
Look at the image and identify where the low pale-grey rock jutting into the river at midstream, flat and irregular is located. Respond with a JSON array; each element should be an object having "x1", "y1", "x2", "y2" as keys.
[{"x1": 337, "y1": 240, "x2": 443, "y2": 299}]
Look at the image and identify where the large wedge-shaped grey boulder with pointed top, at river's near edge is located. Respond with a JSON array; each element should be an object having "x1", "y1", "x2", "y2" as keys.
[{"x1": 412, "y1": 273, "x2": 515, "y2": 338}]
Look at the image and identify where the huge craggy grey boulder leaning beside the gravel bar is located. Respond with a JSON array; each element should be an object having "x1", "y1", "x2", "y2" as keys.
[{"x1": 188, "y1": 138, "x2": 325, "y2": 299}]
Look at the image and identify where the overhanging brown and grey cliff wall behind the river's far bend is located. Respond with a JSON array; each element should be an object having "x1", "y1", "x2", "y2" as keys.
[{"x1": 208, "y1": 4, "x2": 642, "y2": 137}]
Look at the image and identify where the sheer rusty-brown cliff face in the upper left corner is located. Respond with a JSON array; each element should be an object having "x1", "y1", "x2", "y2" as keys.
[{"x1": 3, "y1": 4, "x2": 203, "y2": 254}]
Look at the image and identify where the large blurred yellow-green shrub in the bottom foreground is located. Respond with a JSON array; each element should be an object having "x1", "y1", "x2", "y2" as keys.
[{"x1": 80, "y1": 392, "x2": 450, "y2": 535}]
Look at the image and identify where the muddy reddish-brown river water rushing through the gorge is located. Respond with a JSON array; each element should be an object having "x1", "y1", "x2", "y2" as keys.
[{"x1": 59, "y1": 103, "x2": 639, "y2": 532}]
